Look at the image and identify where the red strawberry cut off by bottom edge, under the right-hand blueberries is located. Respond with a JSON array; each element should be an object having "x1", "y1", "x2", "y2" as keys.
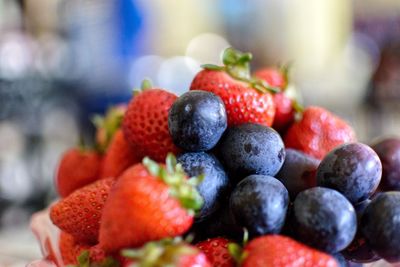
[{"x1": 242, "y1": 235, "x2": 339, "y2": 267}]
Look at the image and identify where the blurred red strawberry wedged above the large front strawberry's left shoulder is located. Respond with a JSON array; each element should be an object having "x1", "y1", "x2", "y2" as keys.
[{"x1": 100, "y1": 130, "x2": 141, "y2": 178}]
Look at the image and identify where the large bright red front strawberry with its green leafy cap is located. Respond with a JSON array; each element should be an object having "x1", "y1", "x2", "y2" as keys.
[{"x1": 99, "y1": 154, "x2": 203, "y2": 251}]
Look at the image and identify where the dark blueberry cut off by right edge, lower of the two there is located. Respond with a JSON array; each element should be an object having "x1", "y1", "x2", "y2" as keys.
[{"x1": 360, "y1": 192, "x2": 400, "y2": 262}]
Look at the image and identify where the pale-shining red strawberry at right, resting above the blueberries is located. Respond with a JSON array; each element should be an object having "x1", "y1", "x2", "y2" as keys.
[{"x1": 284, "y1": 107, "x2": 356, "y2": 159}]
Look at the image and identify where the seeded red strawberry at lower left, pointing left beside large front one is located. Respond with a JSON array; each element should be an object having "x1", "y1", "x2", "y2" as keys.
[{"x1": 50, "y1": 178, "x2": 114, "y2": 244}]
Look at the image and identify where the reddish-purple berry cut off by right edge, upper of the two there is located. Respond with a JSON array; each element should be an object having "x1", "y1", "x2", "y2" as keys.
[{"x1": 372, "y1": 138, "x2": 400, "y2": 191}]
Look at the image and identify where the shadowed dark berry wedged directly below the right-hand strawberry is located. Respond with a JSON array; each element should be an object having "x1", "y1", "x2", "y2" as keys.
[{"x1": 275, "y1": 148, "x2": 319, "y2": 199}]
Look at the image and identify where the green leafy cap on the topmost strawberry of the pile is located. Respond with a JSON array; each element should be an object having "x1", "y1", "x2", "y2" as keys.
[{"x1": 201, "y1": 47, "x2": 281, "y2": 93}]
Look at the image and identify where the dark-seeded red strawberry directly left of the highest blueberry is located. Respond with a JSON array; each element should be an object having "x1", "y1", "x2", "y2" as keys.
[{"x1": 122, "y1": 82, "x2": 179, "y2": 161}]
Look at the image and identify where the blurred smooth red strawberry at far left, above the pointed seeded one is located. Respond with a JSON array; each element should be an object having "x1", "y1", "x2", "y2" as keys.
[{"x1": 56, "y1": 148, "x2": 101, "y2": 197}]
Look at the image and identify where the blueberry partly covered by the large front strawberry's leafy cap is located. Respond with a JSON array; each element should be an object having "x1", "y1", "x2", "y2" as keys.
[{"x1": 177, "y1": 152, "x2": 229, "y2": 220}]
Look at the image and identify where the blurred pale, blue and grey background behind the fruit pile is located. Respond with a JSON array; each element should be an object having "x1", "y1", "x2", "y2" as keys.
[{"x1": 0, "y1": 0, "x2": 400, "y2": 266}]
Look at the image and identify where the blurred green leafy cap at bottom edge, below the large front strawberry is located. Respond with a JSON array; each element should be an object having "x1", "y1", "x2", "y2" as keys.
[{"x1": 121, "y1": 237, "x2": 198, "y2": 267}]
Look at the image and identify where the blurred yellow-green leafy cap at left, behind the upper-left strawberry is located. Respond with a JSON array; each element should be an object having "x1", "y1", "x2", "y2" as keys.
[{"x1": 92, "y1": 105, "x2": 126, "y2": 153}]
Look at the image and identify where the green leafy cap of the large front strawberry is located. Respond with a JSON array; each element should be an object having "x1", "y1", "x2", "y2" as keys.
[{"x1": 143, "y1": 153, "x2": 204, "y2": 215}]
